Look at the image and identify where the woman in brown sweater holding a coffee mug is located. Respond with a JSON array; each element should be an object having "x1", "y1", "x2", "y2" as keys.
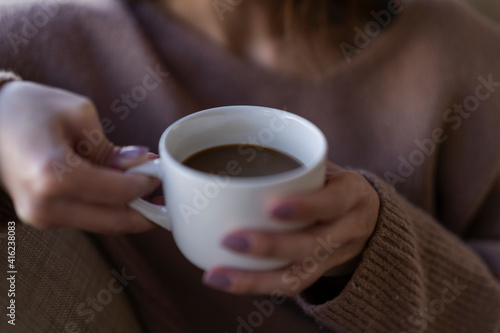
[{"x1": 0, "y1": 0, "x2": 500, "y2": 332}]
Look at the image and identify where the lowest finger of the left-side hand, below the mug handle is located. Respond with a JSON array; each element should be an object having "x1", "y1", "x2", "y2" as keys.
[{"x1": 46, "y1": 201, "x2": 156, "y2": 234}]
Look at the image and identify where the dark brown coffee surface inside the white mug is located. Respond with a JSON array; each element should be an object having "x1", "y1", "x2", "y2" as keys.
[{"x1": 182, "y1": 144, "x2": 303, "y2": 177}]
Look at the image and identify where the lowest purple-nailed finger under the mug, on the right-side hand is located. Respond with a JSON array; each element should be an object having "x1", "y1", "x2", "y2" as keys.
[{"x1": 203, "y1": 262, "x2": 326, "y2": 296}]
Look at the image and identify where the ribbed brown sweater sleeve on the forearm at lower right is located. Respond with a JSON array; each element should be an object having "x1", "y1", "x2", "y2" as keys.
[{"x1": 297, "y1": 172, "x2": 500, "y2": 333}]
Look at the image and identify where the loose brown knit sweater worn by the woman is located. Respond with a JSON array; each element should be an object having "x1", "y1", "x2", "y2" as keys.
[{"x1": 0, "y1": 0, "x2": 500, "y2": 333}]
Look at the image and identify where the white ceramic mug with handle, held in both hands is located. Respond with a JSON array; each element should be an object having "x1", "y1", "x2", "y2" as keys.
[{"x1": 128, "y1": 106, "x2": 327, "y2": 270}]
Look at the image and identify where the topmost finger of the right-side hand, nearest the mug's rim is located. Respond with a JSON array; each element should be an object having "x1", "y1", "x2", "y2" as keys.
[{"x1": 270, "y1": 170, "x2": 367, "y2": 221}]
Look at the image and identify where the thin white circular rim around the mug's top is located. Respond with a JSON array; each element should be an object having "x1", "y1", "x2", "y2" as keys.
[{"x1": 158, "y1": 105, "x2": 328, "y2": 187}]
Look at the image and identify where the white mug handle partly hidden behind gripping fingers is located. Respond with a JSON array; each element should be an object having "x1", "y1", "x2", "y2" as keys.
[{"x1": 125, "y1": 159, "x2": 172, "y2": 231}]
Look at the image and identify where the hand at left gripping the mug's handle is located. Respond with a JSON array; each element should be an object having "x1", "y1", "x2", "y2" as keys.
[{"x1": 0, "y1": 81, "x2": 158, "y2": 233}]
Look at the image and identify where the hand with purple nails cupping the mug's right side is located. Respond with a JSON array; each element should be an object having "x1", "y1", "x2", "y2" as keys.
[{"x1": 203, "y1": 163, "x2": 380, "y2": 296}]
